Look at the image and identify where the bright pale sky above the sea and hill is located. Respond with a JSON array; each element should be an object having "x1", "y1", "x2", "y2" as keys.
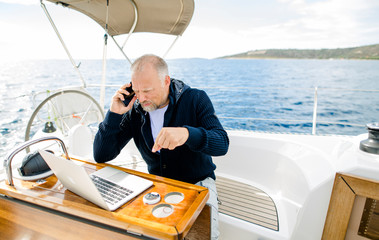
[{"x1": 0, "y1": 0, "x2": 379, "y2": 61}]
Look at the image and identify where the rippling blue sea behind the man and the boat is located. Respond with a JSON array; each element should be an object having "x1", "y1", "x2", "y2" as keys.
[{"x1": 0, "y1": 59, "x2": 379, "y2": 159}]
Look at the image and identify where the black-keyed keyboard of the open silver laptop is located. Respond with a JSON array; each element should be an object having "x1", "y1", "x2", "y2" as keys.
[{"x1": 91, "y1": 175, "x2": 133, "y2": 205}]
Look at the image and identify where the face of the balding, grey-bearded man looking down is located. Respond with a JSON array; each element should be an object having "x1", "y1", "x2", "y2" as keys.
[{"x1": 132, "y1": 65, "x2": 170, "y2": 112}]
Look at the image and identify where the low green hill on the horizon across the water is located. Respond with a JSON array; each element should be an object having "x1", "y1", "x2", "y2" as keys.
[{"x1": 221, "y1": 44, "x2": 379, "y2": 60}]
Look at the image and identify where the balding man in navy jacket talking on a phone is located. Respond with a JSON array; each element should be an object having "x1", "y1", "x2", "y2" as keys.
[{"x1": 94, "y1": 55, "x2": 229, "y2": 239}]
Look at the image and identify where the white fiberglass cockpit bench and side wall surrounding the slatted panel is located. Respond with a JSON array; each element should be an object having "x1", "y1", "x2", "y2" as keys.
[{"x1": 214, "y1": 131, "x2": 379, "y2": 240}]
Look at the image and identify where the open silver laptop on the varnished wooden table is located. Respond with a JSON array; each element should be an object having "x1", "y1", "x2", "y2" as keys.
[{"x1": 38, "y1": 150, "x2": 153, "y2": 211}]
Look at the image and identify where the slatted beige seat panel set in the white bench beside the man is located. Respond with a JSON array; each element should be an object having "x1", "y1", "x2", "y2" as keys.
[{"x1": 216, "y1": 176, "x2": 279, "y2": 231}]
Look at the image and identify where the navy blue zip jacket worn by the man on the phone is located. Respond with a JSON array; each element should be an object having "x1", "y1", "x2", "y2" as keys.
[{"x1": 94, "y1": 79, "x2": 229, "y2": 183}]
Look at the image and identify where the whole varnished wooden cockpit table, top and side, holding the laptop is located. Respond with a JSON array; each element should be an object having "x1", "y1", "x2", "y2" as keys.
[{"x1": 0, "y1": 159, "x2": 210, "y2": 239}]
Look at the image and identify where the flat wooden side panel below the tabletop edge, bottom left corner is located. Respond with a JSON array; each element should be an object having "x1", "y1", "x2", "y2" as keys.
[{"x1": 0, "y1": 198, "x2": 140, "y2": 240}]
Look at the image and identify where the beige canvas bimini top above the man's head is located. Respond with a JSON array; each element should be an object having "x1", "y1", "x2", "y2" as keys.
[{"x1": 48, "y1": 0, "x2": 194, "y2": 36}]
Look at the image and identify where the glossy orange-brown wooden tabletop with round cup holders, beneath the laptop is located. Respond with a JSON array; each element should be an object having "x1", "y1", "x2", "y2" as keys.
[{"x1": 0, "y1": 160, "x2": 209, "y2": 239}]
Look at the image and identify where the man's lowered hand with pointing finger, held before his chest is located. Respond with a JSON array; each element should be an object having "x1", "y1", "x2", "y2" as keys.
[{"x1": 151, "y1": 127, "x2": 189, "y2": 152}]
